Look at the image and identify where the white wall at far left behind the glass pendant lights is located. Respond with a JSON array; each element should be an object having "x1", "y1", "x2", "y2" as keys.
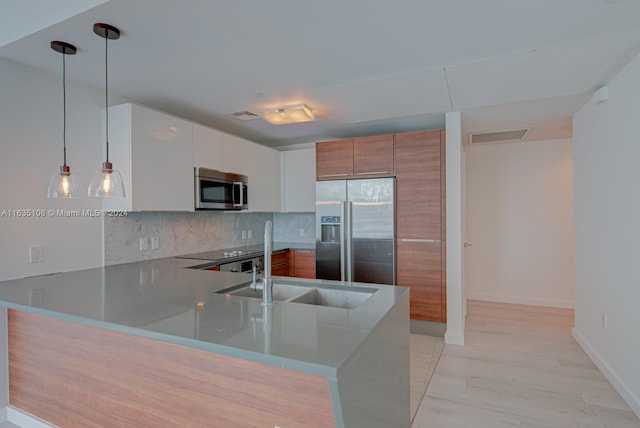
[{"x1": 0, "y1": 59, "x2": 112, "y2": 280}]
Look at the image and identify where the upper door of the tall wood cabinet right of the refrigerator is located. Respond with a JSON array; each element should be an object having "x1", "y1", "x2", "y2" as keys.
[{"x1": 395, "y1": 130, "x2": 442, "y2": 241}]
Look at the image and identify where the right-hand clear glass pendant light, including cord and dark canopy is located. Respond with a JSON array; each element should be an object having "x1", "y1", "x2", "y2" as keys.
[{"x1": 89, "y1": 23, "x2": 125, "y2": 198}]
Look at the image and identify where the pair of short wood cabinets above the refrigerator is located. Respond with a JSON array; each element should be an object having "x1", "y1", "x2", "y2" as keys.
[{"x1": 316, "y1": 135, "x2": 395, "y2": 180}]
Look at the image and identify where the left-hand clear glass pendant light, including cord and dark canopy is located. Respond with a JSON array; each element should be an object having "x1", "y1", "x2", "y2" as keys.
[{"x1": 47, "y1": 40, "x2": 82, "y2": 198}]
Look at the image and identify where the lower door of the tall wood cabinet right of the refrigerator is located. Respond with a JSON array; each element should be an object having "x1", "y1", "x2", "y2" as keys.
[{"x1": 396, "y1": 241, "x2": 443, "y2": 322}]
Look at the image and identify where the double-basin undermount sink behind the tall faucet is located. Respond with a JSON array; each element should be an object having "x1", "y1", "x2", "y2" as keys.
[{"x1": 216, "y1": 283, "x2": 376, "y2": 309}]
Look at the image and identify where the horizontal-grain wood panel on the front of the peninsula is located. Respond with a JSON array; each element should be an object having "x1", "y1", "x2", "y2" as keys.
[{"x1": 8, "y1": 309, "x2": 335, "y2": 428}]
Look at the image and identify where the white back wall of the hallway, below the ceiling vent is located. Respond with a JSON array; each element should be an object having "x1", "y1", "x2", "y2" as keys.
[{"x1": 465, "y1": 139, "x2": 573, "y2": 308}]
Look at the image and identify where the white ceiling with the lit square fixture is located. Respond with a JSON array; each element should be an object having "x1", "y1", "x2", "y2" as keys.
[{"x1": 0, "y1": 0, "x2": 640, "y2": 148}]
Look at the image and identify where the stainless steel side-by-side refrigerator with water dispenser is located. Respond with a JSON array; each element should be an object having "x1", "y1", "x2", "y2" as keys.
[{"x1": 316, "y1": 178, "x2": 396, "y2": 284}]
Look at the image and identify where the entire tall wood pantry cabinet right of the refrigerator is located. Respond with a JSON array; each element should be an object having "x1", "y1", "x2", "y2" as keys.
[{"x1": 395, "y1": 130, "x2": 446, "y2": 322}]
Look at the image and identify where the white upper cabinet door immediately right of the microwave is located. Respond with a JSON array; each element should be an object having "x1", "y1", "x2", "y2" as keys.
[{"x1": 247, "y1": 144, "x2": 280, "y2": 212}]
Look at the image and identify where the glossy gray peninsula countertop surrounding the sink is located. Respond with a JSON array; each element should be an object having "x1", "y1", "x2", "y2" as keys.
[{"x1": 0, "y1": 256, "x2": 408, "y2": 377}]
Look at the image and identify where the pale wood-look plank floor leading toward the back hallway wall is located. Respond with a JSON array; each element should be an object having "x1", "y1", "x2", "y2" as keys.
[{"x1": 412, "y1": 301, "x2": 640, "y2": 428}]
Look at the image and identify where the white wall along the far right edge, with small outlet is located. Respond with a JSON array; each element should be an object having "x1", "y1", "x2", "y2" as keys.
[{"x1": 573, "y1": 51, "x2": 640, "y2": 415}]
